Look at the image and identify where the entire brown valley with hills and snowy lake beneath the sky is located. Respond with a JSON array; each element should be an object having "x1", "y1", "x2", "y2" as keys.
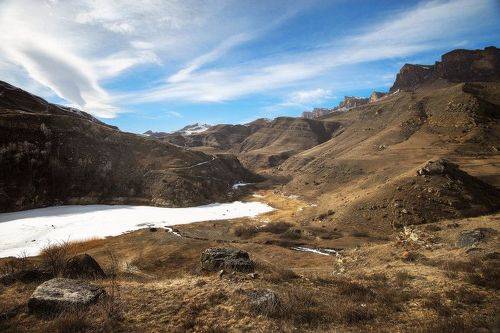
[{"x1": 0, "y1": 47, "x2": 500, "y2": 332}]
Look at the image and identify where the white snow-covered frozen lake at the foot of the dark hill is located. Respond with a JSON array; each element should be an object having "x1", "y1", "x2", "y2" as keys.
[{"x1": 0, "y1": 201, "x2": 273, "y2": 257}]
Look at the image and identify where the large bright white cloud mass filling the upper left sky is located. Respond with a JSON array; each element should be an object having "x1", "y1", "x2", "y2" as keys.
[{"x1": 0, "y1": 0, "x2": 294, "y2": 117}]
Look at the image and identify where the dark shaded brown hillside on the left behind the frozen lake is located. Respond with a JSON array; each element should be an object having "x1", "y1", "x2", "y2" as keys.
[{"x1": 0, "y1": 82, "x2": 254, "y2": 211}]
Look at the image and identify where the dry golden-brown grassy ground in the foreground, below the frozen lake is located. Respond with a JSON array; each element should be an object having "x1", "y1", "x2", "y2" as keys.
[{"x1": 0, "y1": 189, "x2": 500, "y2": 332}]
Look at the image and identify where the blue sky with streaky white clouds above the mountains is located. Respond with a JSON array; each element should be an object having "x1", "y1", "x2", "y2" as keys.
[{"x1": 0, "y1": 0, "x2": 500, "y2": 133}]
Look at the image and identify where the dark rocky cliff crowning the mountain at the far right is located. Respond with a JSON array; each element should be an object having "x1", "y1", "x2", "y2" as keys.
[{"x1": 390, "y1": 46, "x2": 500, "y2": 92}]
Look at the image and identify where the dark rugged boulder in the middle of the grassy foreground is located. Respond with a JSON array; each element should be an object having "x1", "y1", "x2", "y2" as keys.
[{"x1": 200, "y1": 248, "x2": 255, "y2": 272}]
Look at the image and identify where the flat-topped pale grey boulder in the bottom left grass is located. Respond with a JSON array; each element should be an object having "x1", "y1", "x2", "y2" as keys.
[{"x1": 28, "y1": 278, "x2": 106, "y2": 313}]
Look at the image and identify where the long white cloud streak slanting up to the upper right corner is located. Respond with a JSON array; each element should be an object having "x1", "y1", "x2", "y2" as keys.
[{"x1": 131, "y1": 0, "x2": 494, "y2": 102}]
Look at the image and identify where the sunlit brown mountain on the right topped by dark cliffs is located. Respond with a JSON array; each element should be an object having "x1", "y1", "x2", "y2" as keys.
[{"x1": 273, "y1": 47, "x2": 500, "y2": 231}]
